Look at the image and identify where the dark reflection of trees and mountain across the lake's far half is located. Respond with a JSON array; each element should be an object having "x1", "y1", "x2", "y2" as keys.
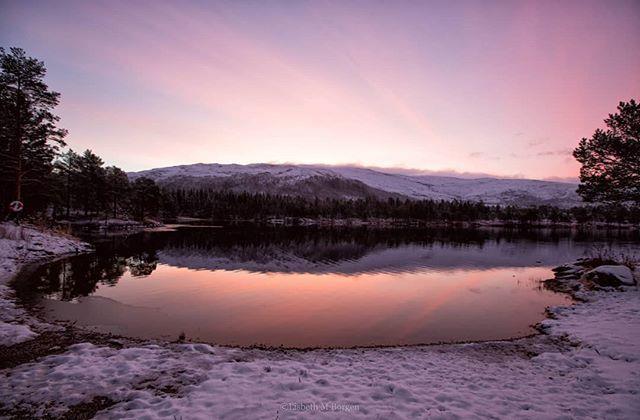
[{"x1": 14, "y1": 227, "x2": 639, "y2": 300}]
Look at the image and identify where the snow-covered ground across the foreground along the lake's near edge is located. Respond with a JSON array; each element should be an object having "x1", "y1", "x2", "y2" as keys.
[{"x1": 0, "y1": 223, "x2": 640, "y2": 419}]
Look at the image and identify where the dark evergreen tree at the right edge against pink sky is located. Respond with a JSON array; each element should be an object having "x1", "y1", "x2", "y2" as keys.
[{"x1": 573, "y1": 99, "x2": 640, "y2": 204}]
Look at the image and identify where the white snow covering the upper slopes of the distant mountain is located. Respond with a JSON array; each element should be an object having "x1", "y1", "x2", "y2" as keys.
[{"x1": 129, "y1": 163, "x2": 581, "y2": 206}]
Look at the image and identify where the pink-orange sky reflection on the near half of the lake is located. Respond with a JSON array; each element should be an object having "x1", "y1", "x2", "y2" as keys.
[{"x1": 86, "y1": 265, "x2": 566, "y2": 346}]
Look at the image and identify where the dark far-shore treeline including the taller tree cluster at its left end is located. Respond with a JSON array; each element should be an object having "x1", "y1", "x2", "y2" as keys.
[{"x1": 5, "y1": 142, "x2": 640, "y2": 224}]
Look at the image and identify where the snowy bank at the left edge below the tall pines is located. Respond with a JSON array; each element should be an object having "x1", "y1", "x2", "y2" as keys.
[{"x1": 0, "y1": 223, "x2": 91, "y2": 345}]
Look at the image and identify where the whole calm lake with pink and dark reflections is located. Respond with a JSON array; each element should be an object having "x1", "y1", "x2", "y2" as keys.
[{"x1": 14, "y1": 226, "x2": 640, "y2": 347}]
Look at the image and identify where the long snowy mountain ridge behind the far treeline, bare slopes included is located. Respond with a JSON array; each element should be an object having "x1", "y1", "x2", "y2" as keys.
[{"x1": 129, "y1": 163, "x2": 582, "y2": 207}]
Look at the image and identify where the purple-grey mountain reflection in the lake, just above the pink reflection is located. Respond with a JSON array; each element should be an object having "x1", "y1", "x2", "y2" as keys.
[{"x1": 158, "y1": 240, "x2": 616, "y2": 274}]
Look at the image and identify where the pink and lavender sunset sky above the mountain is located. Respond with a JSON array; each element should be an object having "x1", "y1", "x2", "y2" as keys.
[{"x1": 0, "y1": 0, "x2": 640, "y2": 179}]
